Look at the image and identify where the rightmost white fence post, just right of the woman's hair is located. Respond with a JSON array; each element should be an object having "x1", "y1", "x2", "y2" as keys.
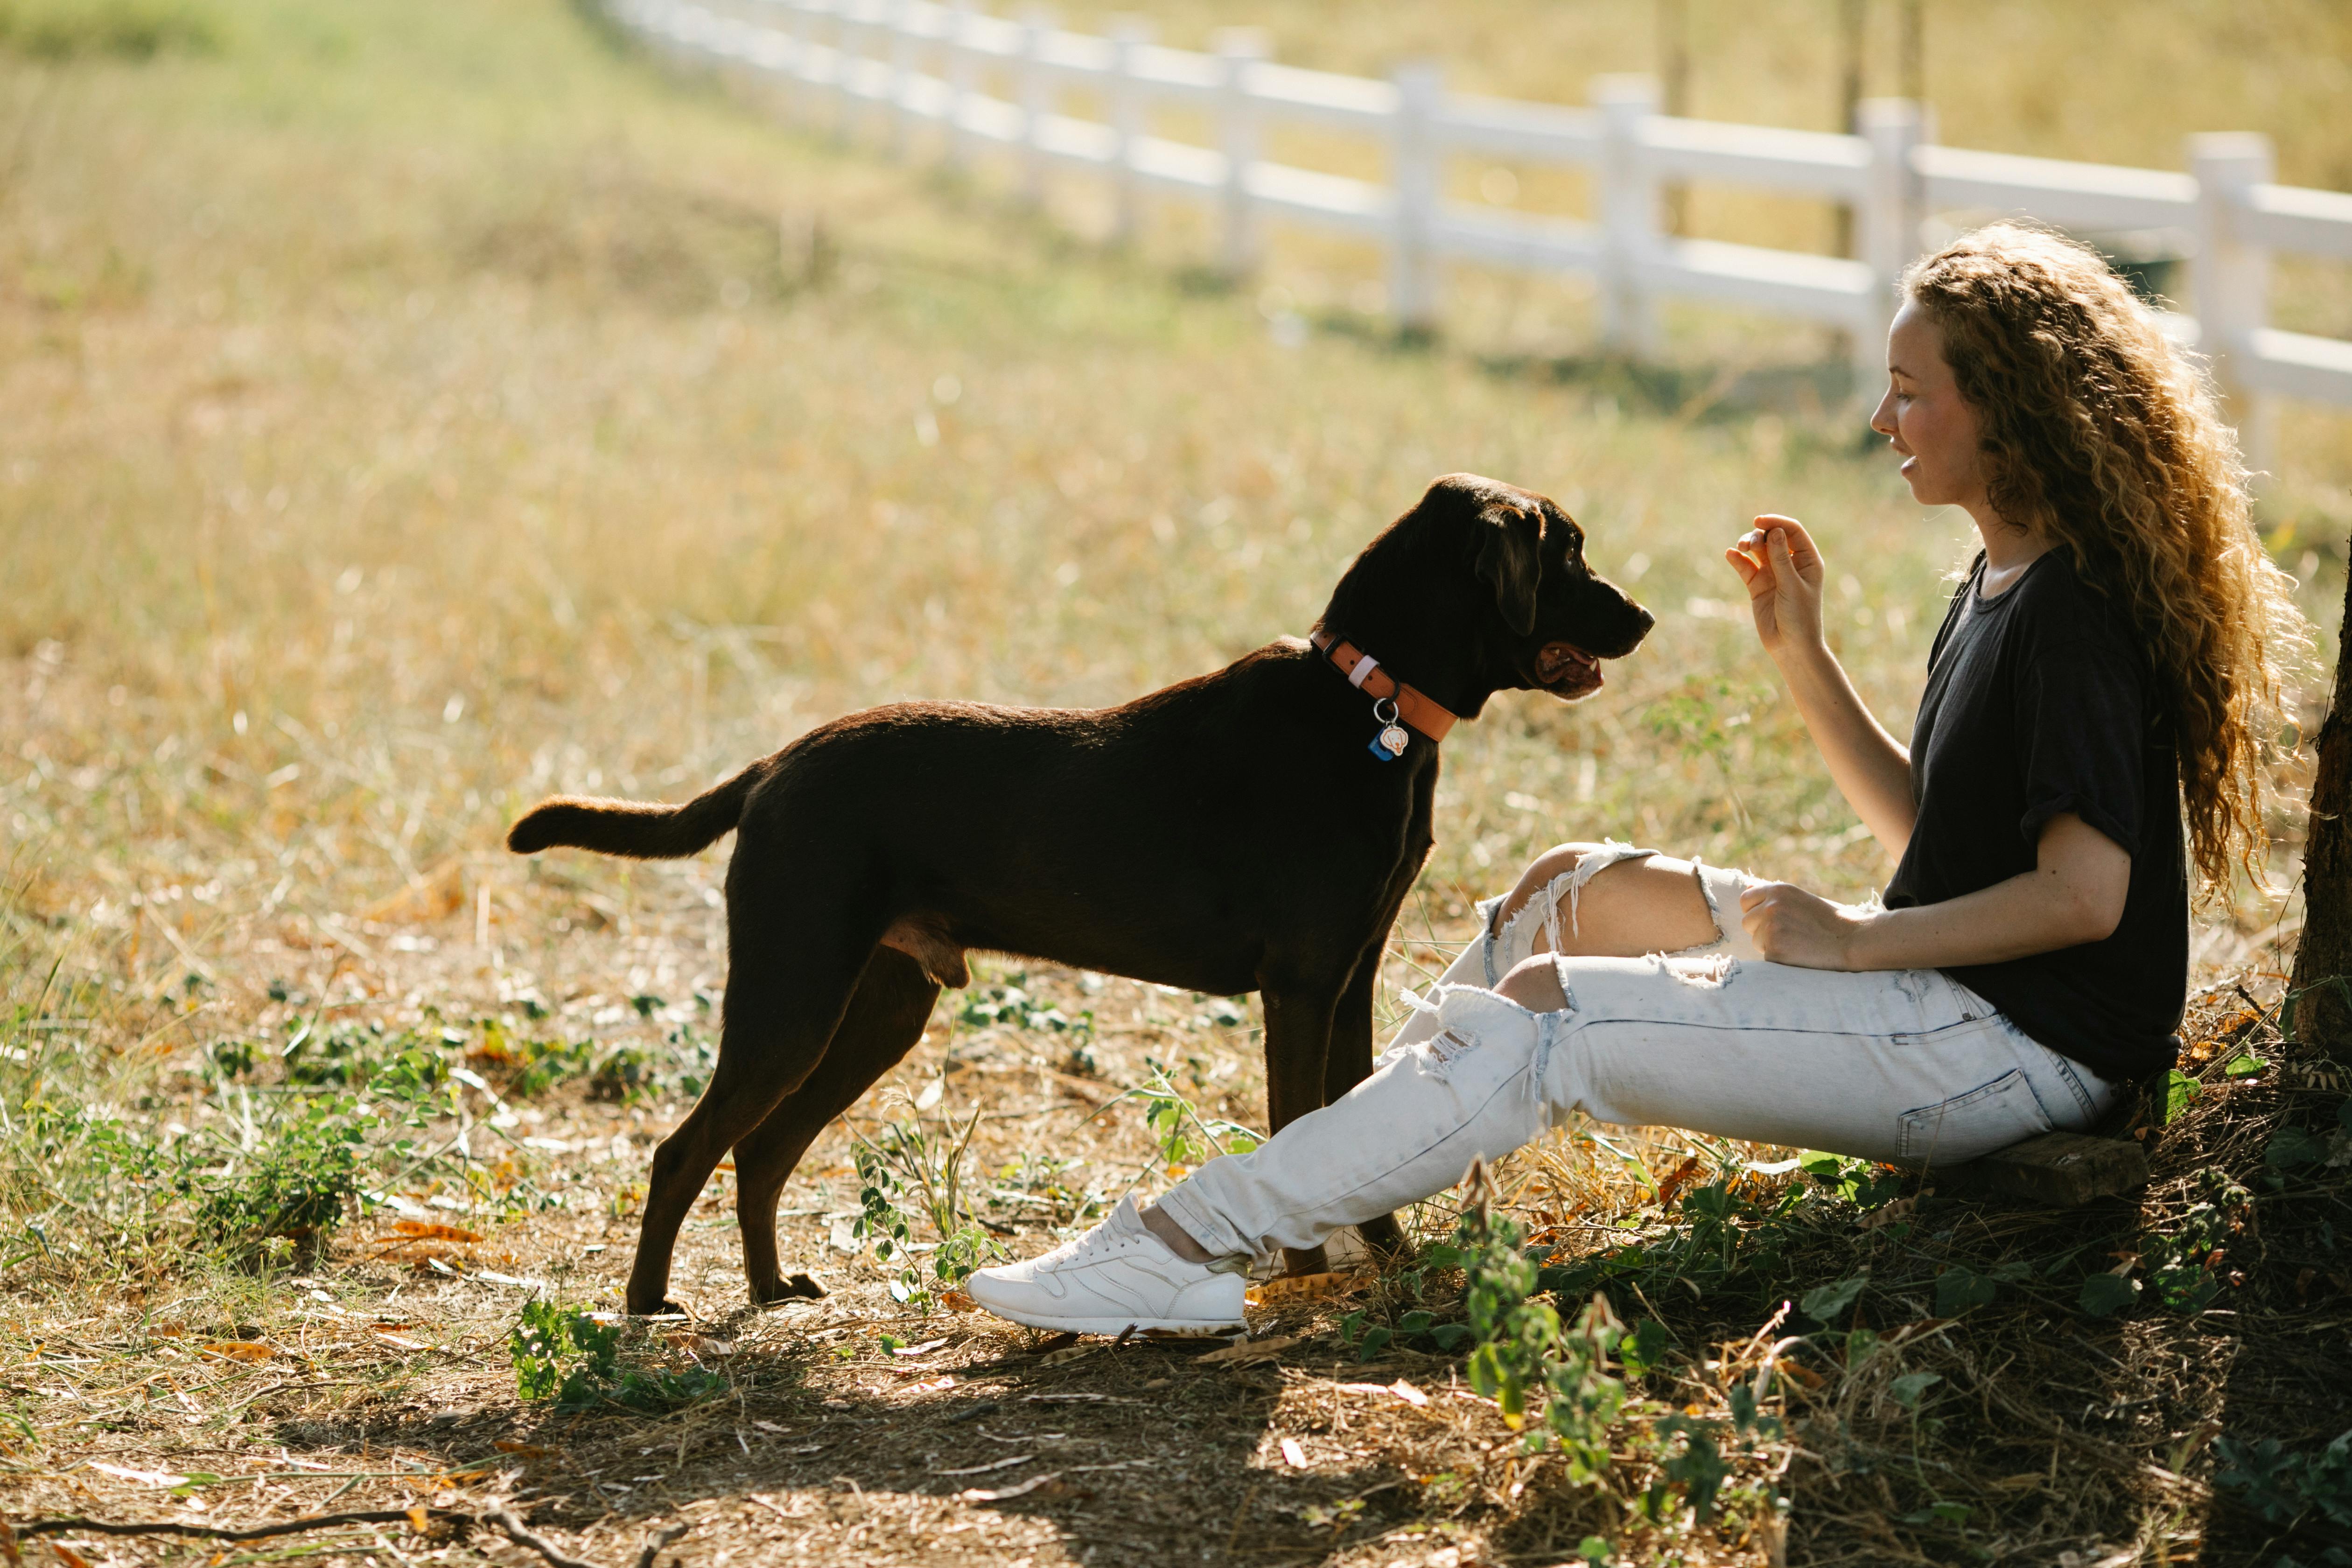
[{"x1": 2190, "y1": 132, "x2": 2277, "y2": 484}]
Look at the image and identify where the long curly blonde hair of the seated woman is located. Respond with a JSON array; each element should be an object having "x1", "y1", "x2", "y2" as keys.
[{"x1": 1903, "y1": 224, "x2": 2312, "y2": 896}]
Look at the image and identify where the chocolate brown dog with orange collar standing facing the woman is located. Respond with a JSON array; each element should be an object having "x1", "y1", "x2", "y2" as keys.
[{"x1": 506, "y1": 475, "x2": 1651, "y2": 1312}]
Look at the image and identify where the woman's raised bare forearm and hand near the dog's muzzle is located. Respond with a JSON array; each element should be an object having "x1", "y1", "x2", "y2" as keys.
[{"x1": 1724, "y1": 515, "x2": 1919, "y2": 861}]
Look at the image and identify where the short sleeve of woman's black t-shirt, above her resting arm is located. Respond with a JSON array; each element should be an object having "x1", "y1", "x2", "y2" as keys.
[{"x1": 2016, "y1": 637, "x2": 2148, "y2": 856}]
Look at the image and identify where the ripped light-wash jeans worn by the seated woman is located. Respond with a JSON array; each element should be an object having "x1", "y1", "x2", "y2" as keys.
[{"x1": 1160, "y1": 844, "x2": 2117, "y2": 1258}]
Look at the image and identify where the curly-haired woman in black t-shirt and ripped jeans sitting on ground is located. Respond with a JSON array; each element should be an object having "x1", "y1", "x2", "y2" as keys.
[{"x1": 969, "y1": 224, "x2": 2310, "y2": 1333}]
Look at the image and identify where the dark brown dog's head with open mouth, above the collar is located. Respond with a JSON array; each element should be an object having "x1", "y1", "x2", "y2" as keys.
[{"x1": 1324, "y1": 473, "x2": 1653, "y2": 717}]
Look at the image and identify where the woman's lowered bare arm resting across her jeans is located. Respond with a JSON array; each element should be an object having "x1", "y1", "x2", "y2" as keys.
[{"x1": 1741, "y1": 811, "x2": 2131, "y2": 968}]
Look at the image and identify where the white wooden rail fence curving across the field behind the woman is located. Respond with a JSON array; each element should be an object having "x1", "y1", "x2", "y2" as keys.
[{"x1": 609, "y1": 0, "x2": 2352, "y2": 454}]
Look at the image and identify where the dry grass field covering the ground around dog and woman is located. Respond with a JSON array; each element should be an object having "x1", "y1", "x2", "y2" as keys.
[{"x1": 0, "y1": 0, "x2": 2352, "y2": 1568}]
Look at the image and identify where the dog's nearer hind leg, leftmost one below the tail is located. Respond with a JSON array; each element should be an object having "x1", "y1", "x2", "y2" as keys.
[{"x1": 628, "y1": 912, "x2": 873, "y2": 1312}]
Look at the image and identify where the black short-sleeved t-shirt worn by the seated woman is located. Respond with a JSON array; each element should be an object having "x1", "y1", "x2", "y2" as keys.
[{"x1": 1886, "y1": 550, "x2": 2190, "y2": 1079}]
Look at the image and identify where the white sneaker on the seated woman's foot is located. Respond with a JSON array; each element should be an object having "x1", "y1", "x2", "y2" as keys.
[{"x1": 964, "y1": 1197, "x2": 1246, "y2": 1333}]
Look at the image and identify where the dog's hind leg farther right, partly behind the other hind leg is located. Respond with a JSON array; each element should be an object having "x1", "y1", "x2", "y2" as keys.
[{"x1": 736, "y1": 947, "x2": 938, "y2": 1305}]
